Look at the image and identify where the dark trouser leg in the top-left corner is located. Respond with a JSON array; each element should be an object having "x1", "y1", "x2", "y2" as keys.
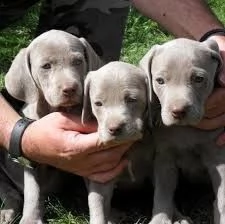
[{"x1": 0, "y1": 0, "x2": 39, "y2": 30}]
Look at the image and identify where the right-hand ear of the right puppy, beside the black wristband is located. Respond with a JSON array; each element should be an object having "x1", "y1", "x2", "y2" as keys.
[{"x1": 202, "y1": 38, "x2": 223, "y2": 73}]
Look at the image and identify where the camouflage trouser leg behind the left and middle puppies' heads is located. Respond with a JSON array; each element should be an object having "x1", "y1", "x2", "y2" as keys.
[{"x1": 37, "y1": 0, "x2": 129, "y2": 62}]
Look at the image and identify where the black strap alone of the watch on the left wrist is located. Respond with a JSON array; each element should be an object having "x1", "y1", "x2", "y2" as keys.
[{"x1": 8, "y1": 117, "x2": 34, "y2": 159}]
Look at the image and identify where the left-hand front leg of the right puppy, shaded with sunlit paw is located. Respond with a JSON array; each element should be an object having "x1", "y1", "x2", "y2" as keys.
[{"x1": 150, "y1": 151, "x2": 177, "y2": 224}]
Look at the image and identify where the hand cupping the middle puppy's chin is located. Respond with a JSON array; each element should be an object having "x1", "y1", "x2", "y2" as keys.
[{"x1": 22, "y1": 112, "x2": 131, "y2": 182}]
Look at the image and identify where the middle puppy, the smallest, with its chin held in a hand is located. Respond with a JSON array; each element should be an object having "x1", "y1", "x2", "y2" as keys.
[{"x1": 82, "y1": 61, "x2": 153, "y2": 224}]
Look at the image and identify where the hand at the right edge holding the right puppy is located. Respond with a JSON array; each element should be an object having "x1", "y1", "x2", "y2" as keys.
[{"x1": 197, "y1": 36, "x2": 225, "y2": 145}]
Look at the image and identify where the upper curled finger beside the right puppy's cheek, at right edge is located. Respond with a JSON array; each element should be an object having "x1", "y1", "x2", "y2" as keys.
[{"x1": 205, "y1": 88, "x2": 225, "y2": 118}]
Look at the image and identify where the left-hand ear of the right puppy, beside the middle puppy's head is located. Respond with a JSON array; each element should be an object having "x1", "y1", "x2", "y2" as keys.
[{"x1": 139, "y1": 45, "x2": 160, "y2": 127}]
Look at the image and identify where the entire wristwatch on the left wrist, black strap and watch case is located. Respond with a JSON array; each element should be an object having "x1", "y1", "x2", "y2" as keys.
[{"x1": 8, "y1": 117, "x2": 35, "y2": 168}]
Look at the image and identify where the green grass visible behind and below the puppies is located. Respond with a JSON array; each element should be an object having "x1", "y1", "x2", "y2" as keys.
[{"x1": 0, "y1": 0, "x2": 225, "y2": 224}]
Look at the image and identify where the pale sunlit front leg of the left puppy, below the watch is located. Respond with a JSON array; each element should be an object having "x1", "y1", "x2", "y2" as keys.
[{"x1": 20, "y1": 168, "x2": 44, "y2": 224}]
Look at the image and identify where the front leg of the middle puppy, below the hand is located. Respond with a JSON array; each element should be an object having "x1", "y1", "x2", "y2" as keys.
[{"x1": 87, "y1": 181, "x2": 114, "y2": 224}]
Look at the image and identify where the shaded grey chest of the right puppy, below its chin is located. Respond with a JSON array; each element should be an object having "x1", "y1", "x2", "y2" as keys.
[{"x1": 153, "y1": 126, "x2": 221, "y2": 182}]
